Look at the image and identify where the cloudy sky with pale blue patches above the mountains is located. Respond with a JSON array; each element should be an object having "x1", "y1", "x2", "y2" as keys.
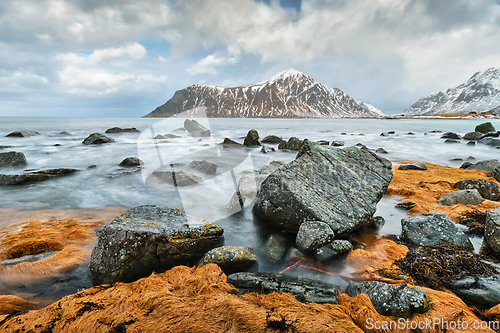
[{"x1": 0, "y1": 0, "x2": 500, "y2": 117}]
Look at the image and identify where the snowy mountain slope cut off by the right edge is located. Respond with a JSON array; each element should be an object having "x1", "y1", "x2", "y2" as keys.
[{"x1": 403, "y1": 68, "x2": 500, "y2": 115}]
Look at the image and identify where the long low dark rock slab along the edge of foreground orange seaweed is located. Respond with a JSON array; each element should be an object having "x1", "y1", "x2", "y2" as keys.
[{"x1": 227, "y1": 273, "x2": 339, "y2": 304}]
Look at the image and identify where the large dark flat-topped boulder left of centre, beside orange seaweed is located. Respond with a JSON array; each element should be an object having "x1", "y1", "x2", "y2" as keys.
[{"x1": 89, "y1": 205, "x2": 223, "y2": 284}]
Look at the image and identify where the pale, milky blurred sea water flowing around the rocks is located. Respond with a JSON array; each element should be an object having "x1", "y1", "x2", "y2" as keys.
[{"x1": 0, "y1": 117, "x2": 500, "y2": 302}]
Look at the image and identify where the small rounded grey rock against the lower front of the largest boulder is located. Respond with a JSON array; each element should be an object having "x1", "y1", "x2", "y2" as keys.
[{"x1": 295, "y1": 221, "x2": 335, "y2": 253}]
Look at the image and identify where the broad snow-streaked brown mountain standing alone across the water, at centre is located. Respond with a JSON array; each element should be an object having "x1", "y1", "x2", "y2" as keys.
[{"x1": 145, "y1": 69, "x2": 380, "y2": 118}]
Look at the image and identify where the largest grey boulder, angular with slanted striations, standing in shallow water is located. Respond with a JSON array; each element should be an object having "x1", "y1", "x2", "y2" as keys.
[{"x1": 253, "y1": 140, "x2": 392, "y2": 236}]
